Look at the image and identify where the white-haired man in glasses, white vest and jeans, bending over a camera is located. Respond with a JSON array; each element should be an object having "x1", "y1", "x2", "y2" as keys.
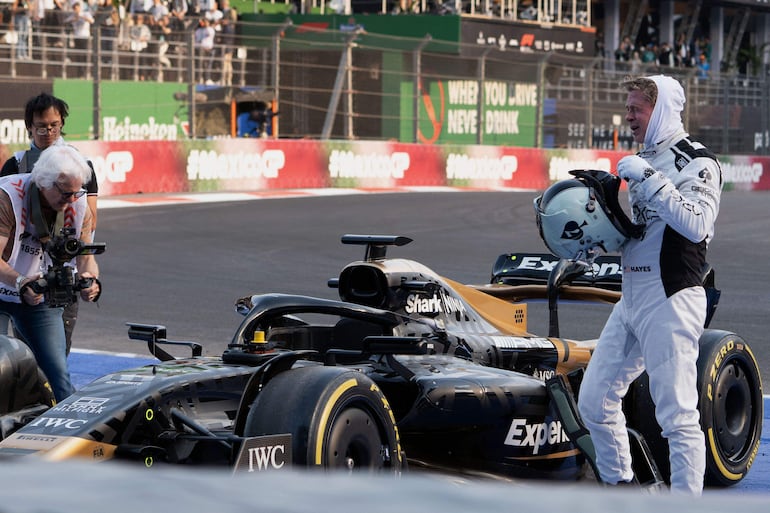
[{"x1": 0, "y1": 144, "x2": 101, "y2": 401}]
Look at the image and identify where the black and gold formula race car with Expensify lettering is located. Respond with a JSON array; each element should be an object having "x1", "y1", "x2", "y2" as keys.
[{"x1": 0, "y1": 235, "x2": 763, "y2": 486}]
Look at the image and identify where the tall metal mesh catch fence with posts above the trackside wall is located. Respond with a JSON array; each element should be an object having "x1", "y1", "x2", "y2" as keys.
[{"x1": 0, "y1": 21, "x2": 770, "y2": 154}]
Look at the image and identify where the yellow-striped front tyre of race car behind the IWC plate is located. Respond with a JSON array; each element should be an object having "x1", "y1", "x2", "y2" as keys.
[{"x1": 244, "y1": 366, "x2": 405, "y2": 474}]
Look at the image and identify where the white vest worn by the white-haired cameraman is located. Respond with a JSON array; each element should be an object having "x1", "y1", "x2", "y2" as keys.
[{"x1": 0, "y1": 174, "x2": 88, "y2": 303}]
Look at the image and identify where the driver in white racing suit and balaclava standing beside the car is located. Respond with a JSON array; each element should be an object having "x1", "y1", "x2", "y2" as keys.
[{"x1": 578, "y1": 75, "x2": 722, "y2": 496}]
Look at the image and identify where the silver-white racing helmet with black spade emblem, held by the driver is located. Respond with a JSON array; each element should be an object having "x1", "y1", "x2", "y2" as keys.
[{"x1": 534, "y1": 169, "x2": 643, "y2": 260}]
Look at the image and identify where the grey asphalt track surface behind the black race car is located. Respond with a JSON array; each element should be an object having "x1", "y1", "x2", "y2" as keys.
[{"x1": 64, "y1": 191, "x2": 770, "y2": 494}]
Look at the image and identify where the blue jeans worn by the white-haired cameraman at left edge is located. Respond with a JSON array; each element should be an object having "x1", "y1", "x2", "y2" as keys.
[{"x1": 0, "y1": 301, "x2": 75, "y2": 402}]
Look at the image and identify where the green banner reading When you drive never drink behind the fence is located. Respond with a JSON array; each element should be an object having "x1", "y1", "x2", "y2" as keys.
[{"x1": 400, "y1": 80, "x2": 538, "y2": 147}]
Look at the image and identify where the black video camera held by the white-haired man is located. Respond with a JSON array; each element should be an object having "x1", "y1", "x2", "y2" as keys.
[{"x1": 29, "y1": 228, "x2": 107, "y2": 308}]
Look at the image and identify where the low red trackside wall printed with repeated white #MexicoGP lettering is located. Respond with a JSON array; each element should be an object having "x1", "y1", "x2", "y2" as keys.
[{"x1": 0, "y1": 138, "x2": 770, "y2": 196}]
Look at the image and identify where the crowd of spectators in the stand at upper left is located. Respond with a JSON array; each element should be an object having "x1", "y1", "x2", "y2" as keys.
[{"x1": 2, "y1": 0, "x2": 238, "y2": 85}]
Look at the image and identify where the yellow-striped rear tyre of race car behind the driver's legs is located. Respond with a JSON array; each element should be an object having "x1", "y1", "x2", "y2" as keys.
[{"x1": 626, "y1": 330, "x2": 764, "y2": 487}]
